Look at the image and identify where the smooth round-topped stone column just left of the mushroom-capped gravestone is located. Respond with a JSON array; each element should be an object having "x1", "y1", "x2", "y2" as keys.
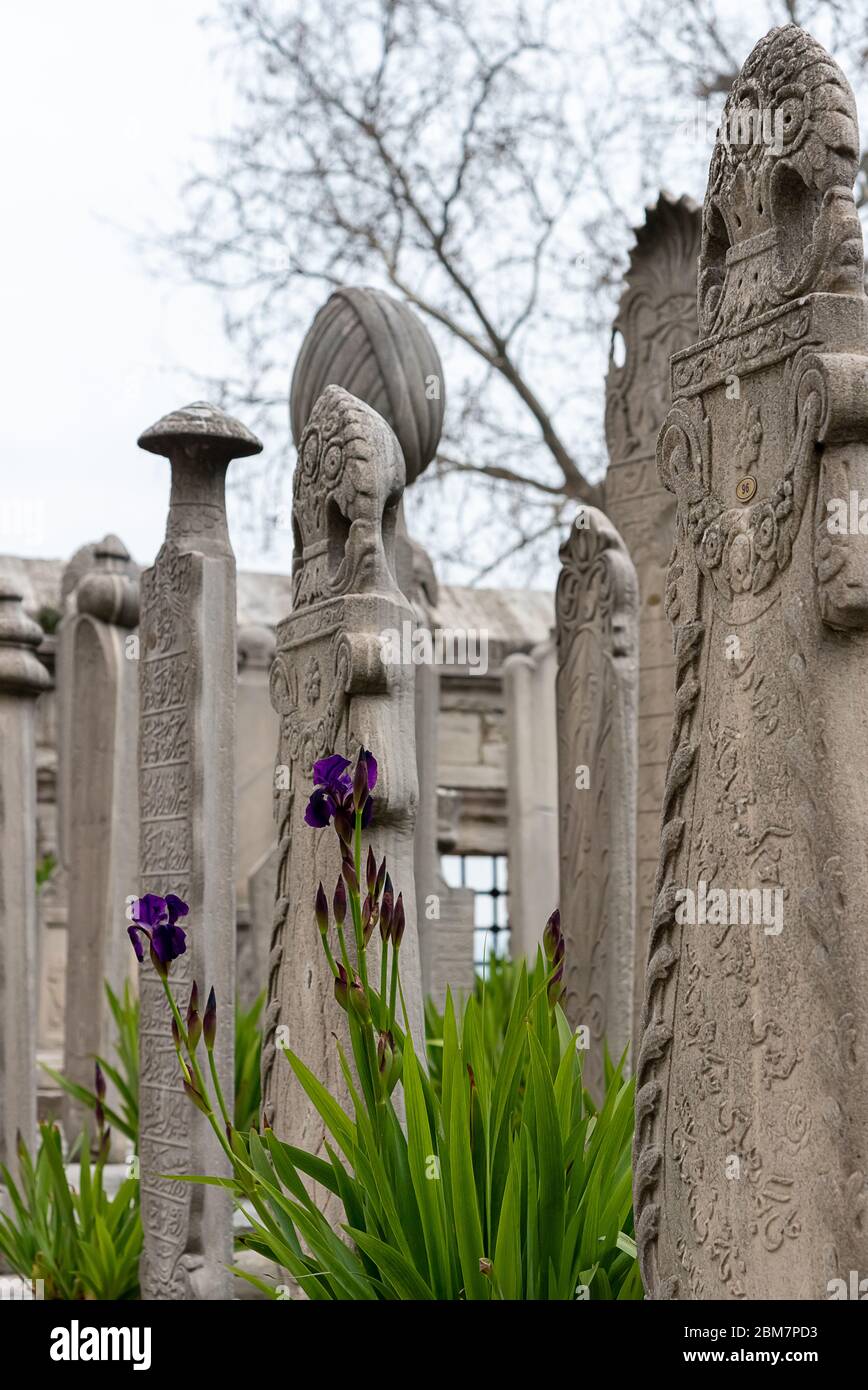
[{"x1": 57, "y1": 535, "x2": 139, "y2": 1156}]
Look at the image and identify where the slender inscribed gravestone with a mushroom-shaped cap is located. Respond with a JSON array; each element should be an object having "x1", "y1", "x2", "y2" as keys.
[{"x1": 139, "y1": 403, "x2": 262, "y2": 1300}]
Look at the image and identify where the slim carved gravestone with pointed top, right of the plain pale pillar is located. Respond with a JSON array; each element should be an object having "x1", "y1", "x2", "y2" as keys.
[{"x1": 555, "y1": 507, "x2": 638, "y2": 1094}]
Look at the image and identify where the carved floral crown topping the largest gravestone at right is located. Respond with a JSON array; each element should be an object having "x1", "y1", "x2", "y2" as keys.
[{"x1": 698, "y1": 25, "x2": 862, "y2": 335}]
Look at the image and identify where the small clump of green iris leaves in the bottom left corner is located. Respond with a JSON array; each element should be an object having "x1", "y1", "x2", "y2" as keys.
[{"x1": 0, "y1": 1123, "x2": 142, "y2": 1301}]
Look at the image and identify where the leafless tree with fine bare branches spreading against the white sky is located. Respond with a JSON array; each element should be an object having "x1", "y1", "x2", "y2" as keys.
[{"x1": 168, "y1": 0, "x2": 868, "y2": 581}]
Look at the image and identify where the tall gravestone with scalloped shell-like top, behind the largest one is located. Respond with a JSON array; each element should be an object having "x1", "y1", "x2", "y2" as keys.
[{"x1": 605, "y1": 193, "x2": 701, "y2": 1045}]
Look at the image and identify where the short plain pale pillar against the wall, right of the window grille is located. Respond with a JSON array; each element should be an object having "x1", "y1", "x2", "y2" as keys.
[{"x1": 504, "y1": 638, "x2": 559, "y2": 962}]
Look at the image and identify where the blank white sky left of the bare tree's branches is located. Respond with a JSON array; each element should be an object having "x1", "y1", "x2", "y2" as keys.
[{"x1": 0, "y1": 0, "x2": 289, "y2": 569}]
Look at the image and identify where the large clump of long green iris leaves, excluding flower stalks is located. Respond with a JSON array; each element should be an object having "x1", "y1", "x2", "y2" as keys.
[{"x1": 226, "y1": 959, "x2": 643, "y2": 1300}]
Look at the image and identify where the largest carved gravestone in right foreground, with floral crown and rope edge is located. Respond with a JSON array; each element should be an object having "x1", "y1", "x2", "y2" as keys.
[{"x1": 634, "y1": 26, "x2": 868, "y2": 1300}]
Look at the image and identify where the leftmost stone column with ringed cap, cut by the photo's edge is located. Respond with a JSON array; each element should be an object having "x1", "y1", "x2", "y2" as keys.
[{"x1": 0, "y1": 577, "x2": 50, "y2": 1170}]
